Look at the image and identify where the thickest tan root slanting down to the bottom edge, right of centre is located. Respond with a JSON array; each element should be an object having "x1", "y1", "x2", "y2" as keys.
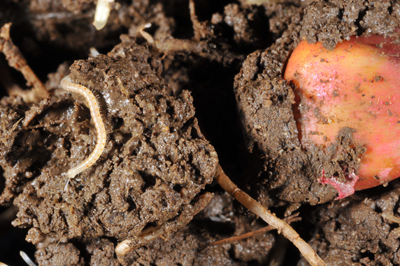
[{"x1": 216, "y1": 165, "x2": 326, "y2": 266}]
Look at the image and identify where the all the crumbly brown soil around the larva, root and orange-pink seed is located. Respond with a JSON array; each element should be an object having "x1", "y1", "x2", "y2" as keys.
[{"x1": 0, "y1": 0, "x2": 400, "y2": 266}]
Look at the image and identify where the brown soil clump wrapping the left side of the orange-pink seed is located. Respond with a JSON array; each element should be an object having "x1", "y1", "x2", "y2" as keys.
[{"x1": 235, "y1": 0, "x2": 400, "y2": 204}]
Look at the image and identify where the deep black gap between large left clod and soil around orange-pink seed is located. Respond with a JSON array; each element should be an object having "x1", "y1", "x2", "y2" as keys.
[{"x1": 181, "y1": 60, "x2": 260, "y2": 187}]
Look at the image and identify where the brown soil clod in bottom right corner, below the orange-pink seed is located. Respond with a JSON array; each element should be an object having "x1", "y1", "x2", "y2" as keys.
[{"x1": 304, "y1": 180, "x2": 400, "y2": 266}]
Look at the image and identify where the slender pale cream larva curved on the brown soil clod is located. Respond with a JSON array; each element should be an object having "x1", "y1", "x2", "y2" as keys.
[{"x1": 60, "y1": 76, "x2": 107, "y2": 178}]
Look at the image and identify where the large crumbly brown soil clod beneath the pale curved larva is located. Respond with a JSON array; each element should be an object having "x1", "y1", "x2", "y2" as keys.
[{"x1": 0, "y1": 37, "x2": 218, "y2": 256}]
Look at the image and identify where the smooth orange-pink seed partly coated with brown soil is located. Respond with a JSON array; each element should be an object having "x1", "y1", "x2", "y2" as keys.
[{"x1": 284, "y1": 36, "x2": 400, "y2": 196}]
